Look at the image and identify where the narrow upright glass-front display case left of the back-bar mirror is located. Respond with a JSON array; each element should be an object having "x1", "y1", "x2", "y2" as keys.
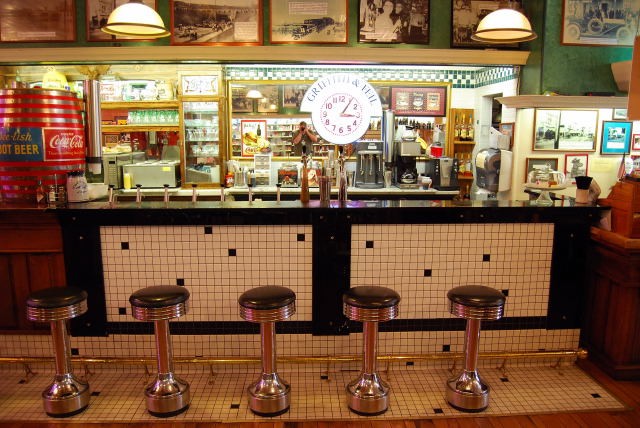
[{"x1": 180, "y1": 98, "x2": 222, "y2": 185}]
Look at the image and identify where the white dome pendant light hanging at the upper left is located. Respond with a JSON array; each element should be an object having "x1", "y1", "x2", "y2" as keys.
[{"x1": 102, "y1": 0, "x2": 171, "y2": 39}]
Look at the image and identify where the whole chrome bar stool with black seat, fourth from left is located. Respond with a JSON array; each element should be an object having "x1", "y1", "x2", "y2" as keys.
[{"x1": 342, "y1": 286, "x2": 400, "y2": 416}]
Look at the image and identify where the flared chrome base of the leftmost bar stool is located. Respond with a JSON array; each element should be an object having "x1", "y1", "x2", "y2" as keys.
[{"x1": 42, "y1": 373, "x2": 91, "y2": 418}]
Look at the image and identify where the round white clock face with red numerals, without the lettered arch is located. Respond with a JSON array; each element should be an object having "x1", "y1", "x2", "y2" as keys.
[{"x1": 311, "y1": 92, "x2": 369, "y2": 142}]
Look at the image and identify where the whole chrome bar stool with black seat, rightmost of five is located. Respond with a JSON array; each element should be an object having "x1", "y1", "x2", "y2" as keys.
[{"x1": 446, "y1": 285, "x2": 505, "y2": 412}]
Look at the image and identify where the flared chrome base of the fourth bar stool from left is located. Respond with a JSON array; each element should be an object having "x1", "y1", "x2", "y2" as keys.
[{"x1": 346, "y1": 373, "x2": 389, "y2": 416}]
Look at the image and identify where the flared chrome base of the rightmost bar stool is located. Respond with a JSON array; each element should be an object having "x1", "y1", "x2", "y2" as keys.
[{"x1": 446, "y1": 370, "x2": 489, "y2": 412}]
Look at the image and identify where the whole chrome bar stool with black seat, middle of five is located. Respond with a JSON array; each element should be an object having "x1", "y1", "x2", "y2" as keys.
[{"x1": 238, "y1": 286, "x2": 296, "y2": 416}]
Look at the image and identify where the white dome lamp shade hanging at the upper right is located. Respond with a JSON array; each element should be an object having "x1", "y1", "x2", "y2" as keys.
[{"x1": 471, "y1": 9, "x2": 538, "y2": 44}]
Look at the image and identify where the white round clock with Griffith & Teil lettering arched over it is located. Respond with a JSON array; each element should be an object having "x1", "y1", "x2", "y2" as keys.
[{"x1": 300, "y1": 73, "x2": 382, "y2": 144}]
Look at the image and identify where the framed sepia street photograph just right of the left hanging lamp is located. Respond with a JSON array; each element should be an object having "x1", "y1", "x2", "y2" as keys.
[{"x1": 170, "y1": 0, "x2": 262, "y2": 45}]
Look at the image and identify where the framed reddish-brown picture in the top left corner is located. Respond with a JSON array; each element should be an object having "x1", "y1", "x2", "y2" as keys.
[{"x1": 0, "y1": 0, "x2": 76, "y2": 43}]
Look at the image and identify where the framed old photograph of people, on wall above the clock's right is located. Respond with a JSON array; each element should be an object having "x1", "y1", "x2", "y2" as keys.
[{"x1": 358, "y1": 0, "x2": 430, "y2": 45}]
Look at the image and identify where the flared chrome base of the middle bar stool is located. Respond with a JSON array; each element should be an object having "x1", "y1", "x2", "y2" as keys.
[{"x1": 247, "y1": 373, "x2": 291, "y2": 416}]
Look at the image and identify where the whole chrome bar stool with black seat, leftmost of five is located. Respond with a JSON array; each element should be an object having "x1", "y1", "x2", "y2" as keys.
[{"x1": 27, "y1": 287, "x2": 91, "y2": 417}]
